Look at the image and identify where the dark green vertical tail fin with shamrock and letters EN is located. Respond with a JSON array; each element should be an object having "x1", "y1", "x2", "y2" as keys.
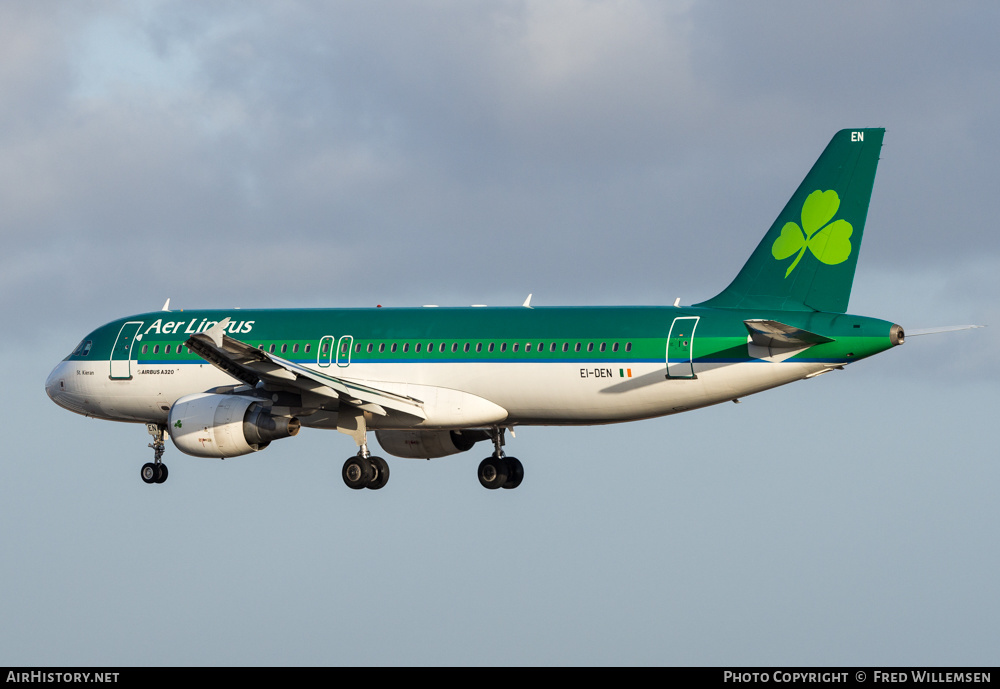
[{"x1": 695, "y1": 129, "x2": 885, "y2": 313}]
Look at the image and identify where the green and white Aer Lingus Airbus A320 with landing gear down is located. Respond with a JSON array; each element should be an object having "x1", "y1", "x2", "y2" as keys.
[{"x1": 45, "y1": 128, "x2": 920, "y2": 489}]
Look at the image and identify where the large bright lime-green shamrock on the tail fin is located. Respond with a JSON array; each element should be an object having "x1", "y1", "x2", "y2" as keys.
[{"x1": 771, "y1": 189, "x2": 854, "y2": 278}]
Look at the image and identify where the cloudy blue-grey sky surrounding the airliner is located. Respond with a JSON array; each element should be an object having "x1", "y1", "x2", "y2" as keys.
[{"x1": 0, "y1": 0, "x2": 1000, "y2": 666}]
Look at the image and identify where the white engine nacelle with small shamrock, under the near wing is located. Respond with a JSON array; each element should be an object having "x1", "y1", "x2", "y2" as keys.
[{"x1": 168, "y1": 392, "x2": 300, "y2": 459}]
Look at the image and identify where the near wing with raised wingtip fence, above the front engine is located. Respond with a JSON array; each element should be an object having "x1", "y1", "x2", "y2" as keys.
[{"x1": 185, "y1": 317, "x2": 427, "y2": 419}]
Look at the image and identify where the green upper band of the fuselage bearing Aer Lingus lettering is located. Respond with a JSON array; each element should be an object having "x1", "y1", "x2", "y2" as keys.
[{"x1": 67, "y1": 306, "x2": 892, "y2": 367}]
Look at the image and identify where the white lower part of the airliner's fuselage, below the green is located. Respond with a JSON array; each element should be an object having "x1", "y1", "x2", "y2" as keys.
[{"x1": 46, "y1": 360, "x2": 831, "y2": 429}]
